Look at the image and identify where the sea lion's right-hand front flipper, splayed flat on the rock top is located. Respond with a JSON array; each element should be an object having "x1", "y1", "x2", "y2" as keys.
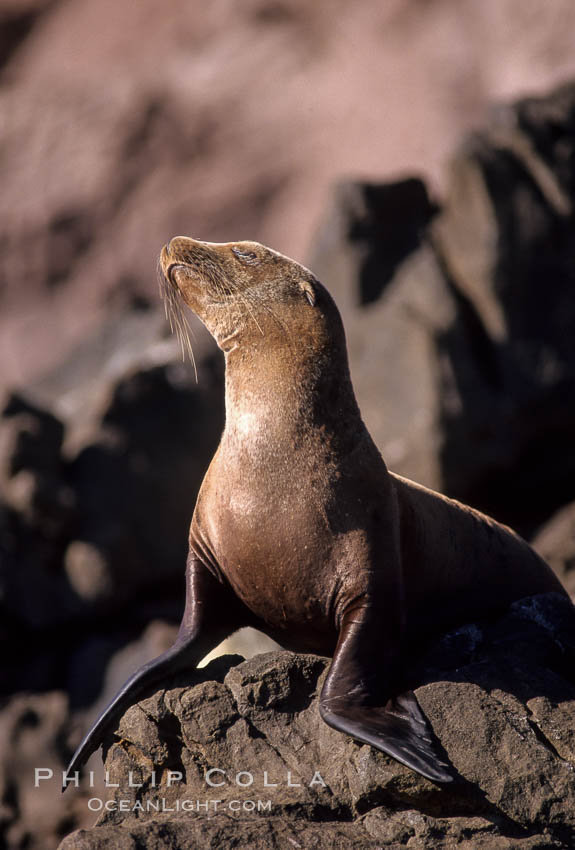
[{"x1": 320, "y1": 608, "x2": 454, "y2": 782}]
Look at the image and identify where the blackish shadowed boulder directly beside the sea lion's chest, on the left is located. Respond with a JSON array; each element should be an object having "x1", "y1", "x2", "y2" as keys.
[{"x1": 64, "y1": 360, "x2": 223, "y2": 605}]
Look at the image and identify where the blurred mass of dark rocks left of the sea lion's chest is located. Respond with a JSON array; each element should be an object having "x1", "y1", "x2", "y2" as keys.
[{"x1": 0, "y1": 305, "x2": 223, "y2": 706}]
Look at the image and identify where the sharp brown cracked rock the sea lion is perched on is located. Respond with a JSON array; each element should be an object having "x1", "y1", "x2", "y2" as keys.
[{"x1": 55, "y1": 594, "x2": 575, "y2": 850}]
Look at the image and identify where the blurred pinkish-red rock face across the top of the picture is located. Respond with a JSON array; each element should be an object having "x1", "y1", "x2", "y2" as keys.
[{"x1": 0, "y1": 0, "x2": 575, "y2": 388}]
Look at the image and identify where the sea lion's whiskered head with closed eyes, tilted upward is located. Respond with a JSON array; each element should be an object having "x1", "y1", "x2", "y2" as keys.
[{"x1": 160, "y1": 236, "x2": 341, "y2": 351}]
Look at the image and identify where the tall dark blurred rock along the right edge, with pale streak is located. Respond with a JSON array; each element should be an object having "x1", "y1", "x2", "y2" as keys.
[{"x1": 433, "y1": 79, "x2": 575, "y2": 533}]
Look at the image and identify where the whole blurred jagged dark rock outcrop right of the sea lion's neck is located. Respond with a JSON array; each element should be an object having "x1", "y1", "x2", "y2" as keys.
[{"x1": 311, "y1": 85, "x2": 575, "y2": 534}]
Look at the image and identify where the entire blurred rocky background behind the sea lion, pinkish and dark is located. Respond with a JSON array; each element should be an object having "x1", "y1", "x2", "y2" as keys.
[{"x1": 0, "y1": 0, "x2": 575, "y2": 848}]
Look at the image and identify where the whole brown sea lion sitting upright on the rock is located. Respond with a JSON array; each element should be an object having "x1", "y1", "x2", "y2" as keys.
[{"x1": 68, "y1": 237, "x2": 565, "y2": 782}]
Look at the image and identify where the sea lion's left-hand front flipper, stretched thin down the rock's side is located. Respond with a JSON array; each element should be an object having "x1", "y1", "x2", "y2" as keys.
[{"x1": 62, "y1": 554, "x2": 245, "y2": 791}]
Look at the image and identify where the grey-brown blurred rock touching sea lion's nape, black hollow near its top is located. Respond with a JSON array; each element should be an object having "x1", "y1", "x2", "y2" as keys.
[{"x1": 310, "y1": 180, "x2": 456, "y2": 496}]
